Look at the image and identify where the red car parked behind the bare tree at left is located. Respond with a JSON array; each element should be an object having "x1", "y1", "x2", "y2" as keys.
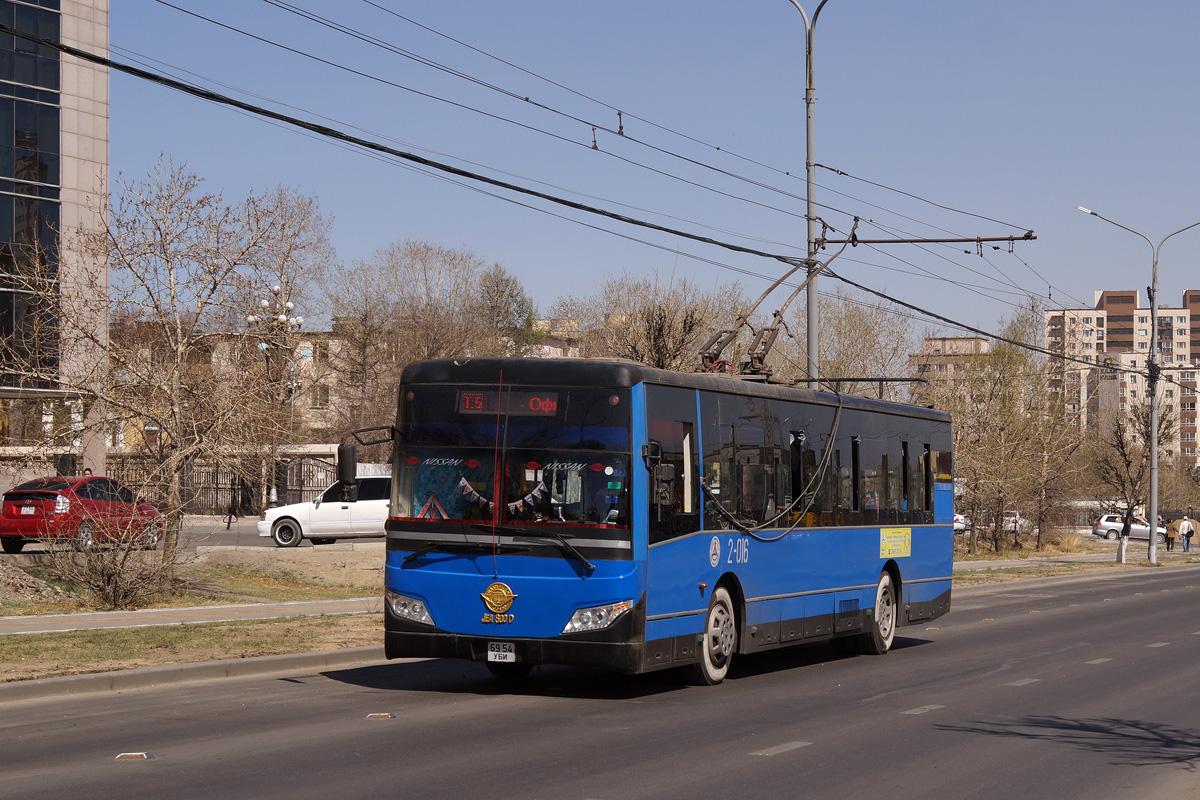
[{"x1": 0, "y1": 476, "x2": 162, "y2": 553}]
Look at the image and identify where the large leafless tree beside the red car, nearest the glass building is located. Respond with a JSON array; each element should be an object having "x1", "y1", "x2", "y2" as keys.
[{"x1": 1, "y1": 162, "x2": 330, "y2": 606}]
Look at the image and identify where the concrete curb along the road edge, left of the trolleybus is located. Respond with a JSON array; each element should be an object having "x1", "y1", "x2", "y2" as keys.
[{"x1": 0, "y1": 645, "x2": 385, "y2": 703}]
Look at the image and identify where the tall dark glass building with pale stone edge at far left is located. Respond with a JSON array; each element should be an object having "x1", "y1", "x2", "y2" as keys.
[{"x1": 0, "y1": 0, "x2": 108, "y2": 463}]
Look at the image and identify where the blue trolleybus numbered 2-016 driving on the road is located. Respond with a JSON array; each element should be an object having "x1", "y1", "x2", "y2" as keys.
[{"x1": 385, "y1": 359, "x2": 954, "y2": 684}]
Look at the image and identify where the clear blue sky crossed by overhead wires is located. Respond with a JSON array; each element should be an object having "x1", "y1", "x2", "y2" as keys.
[{"x1": 109, "y1": 0, "x2": 1200, "y2": 330}]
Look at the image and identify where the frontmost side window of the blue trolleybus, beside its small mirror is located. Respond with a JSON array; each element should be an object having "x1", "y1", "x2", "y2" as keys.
[{"x1": 642, "y1": 385, "x2": 701, "y2": 543}]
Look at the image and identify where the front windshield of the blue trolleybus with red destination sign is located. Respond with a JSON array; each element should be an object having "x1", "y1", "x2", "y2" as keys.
[{"x1": 396, "y1": 384, "x2": 630, "y2": 530}]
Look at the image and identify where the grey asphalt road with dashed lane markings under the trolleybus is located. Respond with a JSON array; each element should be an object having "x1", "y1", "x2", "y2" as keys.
[{"x1": 0, "y1": 567, "x2": 1200, "y2": 800}]
